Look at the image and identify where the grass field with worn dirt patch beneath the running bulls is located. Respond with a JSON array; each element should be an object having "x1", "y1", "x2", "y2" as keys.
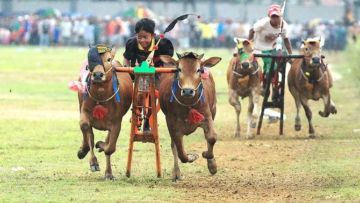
[{"x1": 0, "y1": 44, "x2": 360, "y2": 202}]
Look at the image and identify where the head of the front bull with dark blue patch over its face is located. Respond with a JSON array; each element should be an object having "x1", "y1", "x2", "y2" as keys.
[{"x1": 88, "y1": 44, "x2": 115, "y2": 83}]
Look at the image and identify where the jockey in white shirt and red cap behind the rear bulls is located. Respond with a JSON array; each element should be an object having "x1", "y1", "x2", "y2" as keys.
[{"x1": 249, "y1": 4, "x2": 292, "y2": 100}]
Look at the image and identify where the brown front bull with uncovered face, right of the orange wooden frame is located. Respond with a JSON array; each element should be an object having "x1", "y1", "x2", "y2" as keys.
[{"x1": 159, "y1": 52, "x2": 221, "y2": 181}]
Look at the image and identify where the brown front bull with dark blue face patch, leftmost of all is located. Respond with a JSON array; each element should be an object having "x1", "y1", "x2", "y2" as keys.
[{"x1": 78, "y1": 45, "x2": 133, "y2": 179}]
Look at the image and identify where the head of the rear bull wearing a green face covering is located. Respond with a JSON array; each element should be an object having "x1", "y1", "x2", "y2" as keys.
[{"x1": 233, "y1": 38, "x2": 257, "y2": 75}]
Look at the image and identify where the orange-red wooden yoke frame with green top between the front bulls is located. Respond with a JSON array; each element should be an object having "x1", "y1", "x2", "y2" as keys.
[{"x1": 115, "y1": 61, "x2": 177, "y2": 177}]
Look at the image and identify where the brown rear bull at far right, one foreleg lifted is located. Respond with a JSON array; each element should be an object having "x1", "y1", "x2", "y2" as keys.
[{"x1": 288, "y1": 39, "x2": 337, "y2": 138}]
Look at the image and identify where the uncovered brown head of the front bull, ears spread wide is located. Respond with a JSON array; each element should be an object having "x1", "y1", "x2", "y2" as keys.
[{"x1": 160, "y1": 52, "x2": 221, "y2": 97}]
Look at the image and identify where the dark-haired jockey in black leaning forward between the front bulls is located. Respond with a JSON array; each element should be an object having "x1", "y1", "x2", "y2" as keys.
[{"x1": 124, "y1": 18, "x2": 174, "y2": 79}]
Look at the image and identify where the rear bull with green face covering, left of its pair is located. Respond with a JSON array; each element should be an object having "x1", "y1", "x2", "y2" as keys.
[{"x1": 227, "y1": 39, "x2": 262, "y2": 139}]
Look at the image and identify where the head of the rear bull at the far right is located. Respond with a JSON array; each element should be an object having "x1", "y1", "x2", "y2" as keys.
[{"x1": 300, "y1": 38, "x2": 323, "y2": 66}]
